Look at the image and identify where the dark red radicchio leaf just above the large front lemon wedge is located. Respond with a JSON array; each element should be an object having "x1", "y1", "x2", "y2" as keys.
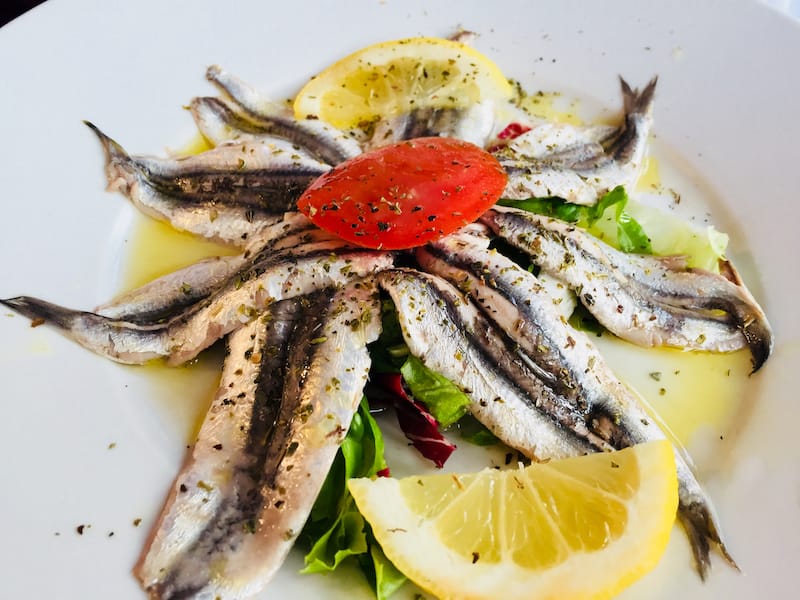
[{"x1": 370, "y1": 373, "x2": 456, "y2": 468}]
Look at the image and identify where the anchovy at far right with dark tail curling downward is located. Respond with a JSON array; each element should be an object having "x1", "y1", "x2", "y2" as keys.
[{"x1": 481, "y1": 207, "x2": 772, "y2": 371}]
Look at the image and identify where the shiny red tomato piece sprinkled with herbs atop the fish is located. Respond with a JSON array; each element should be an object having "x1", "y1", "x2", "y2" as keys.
[{"x1": 297, "y1": 137, "x2": 507, "y2": 250}]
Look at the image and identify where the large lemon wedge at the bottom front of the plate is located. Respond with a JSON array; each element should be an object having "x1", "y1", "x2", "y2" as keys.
[{"x1": 349, "y1": 441, "x2": 678, "y2": 600}]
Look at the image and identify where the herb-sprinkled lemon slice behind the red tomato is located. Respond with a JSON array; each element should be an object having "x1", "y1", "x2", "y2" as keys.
[{"x1": 294, "y1": 37, "x2": 512, "y2": 129}]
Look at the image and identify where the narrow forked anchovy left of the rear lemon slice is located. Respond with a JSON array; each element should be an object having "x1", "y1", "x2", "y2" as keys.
[{"x1": 206, "y1": 65, "x2": 361, "y2": 165}]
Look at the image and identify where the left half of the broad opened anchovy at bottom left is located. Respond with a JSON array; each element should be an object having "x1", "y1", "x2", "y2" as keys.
[{"x1": 134, "y1": 299, "x2": 303, "y2": 598}]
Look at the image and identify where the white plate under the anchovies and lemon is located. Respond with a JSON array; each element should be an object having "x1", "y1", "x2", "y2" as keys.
[{"x1": 0, "y1": 0, "x2": 800, "y2": 599}]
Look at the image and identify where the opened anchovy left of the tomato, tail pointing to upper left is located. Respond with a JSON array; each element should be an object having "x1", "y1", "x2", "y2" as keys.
[{"x1": 87, "y1": 123, "x2": 330, "y2": 247}]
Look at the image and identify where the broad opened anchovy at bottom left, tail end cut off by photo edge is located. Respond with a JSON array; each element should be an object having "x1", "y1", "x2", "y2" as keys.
[{"x1": 139, "y1": 281, "x2": 380, "y2": 599}]
